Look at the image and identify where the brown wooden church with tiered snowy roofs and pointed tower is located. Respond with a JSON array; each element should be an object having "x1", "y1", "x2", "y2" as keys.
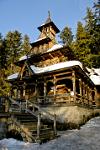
[{"x1": 8, "y1": 14, "x2": 96, "y2": 107}]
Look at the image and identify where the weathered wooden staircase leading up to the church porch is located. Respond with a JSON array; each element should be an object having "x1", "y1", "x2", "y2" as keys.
[{"x1": 7, "y1": 98, "x2": 56, "y2": 143}]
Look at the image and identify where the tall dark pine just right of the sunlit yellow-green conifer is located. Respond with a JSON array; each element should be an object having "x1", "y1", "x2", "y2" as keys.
[{"x1": 85, "y1": 9, "x2": 100, "y2": 67}]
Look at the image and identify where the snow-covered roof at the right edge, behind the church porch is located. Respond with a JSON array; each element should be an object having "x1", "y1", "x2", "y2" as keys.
[{"x1": 87, "y1": 68, "x2": 100, "y2": 85}]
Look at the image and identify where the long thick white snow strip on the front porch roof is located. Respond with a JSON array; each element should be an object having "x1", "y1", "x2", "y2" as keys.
[{"x1": 30, "y1": 60, "x2": 83, "y2": 74}]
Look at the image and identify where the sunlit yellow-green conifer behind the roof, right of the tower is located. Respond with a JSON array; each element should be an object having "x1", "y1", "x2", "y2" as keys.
[{"x1": 72, "y1": 22, "x2": 91, "y2": 66}]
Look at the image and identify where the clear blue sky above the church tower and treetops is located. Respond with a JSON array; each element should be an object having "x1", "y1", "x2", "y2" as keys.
[{"x1": 0, "y1": 0, "x2": 95, "y2": 42}]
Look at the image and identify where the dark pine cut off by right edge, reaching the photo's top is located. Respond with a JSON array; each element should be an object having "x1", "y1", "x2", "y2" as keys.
[{"x1": 91, "y1": 0, "x2": 100, "y2": 67}]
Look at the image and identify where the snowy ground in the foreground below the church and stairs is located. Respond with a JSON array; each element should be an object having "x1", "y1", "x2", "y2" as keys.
[{"x1": 0, "y1": 117, "x2": 100, "y2": 150}]
